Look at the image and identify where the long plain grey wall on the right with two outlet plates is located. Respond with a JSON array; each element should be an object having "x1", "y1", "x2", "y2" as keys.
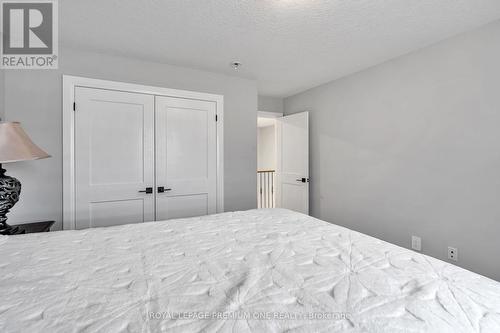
[{"x1": 285, "y1": 22, "x2": 500, "y2": 280}]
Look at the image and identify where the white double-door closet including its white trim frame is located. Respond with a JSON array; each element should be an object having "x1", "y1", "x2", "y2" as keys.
[{"x1": 63, "y1": 76, "x2": 224, "y2": 229}]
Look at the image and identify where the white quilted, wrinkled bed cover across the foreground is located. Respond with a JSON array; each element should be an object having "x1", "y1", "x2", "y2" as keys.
[{"x1": 0, "y1": 209, "x2": 500, "y2": 333}]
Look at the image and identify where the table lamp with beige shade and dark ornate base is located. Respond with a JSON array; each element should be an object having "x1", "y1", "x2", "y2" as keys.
[{"x1": 0, "y1": 122, "x2": 50, "y2": 235}]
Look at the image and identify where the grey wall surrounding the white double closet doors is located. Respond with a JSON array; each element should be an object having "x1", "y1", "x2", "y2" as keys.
[{"x1": 5, "y1": 48, "x2": 257, "y2": 228}]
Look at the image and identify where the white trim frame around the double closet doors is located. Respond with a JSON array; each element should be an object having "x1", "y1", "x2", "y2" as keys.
[{"x1": 62, "y1": 75, "x2": 224, "y2": 230}]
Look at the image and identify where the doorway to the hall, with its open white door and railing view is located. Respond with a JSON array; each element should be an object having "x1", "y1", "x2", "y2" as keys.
[{"x1": 257, "y1": 111, "x2": 309, "y2": 214}]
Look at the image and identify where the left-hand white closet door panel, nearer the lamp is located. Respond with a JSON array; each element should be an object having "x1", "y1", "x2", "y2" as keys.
[{"x1": 75, "y1": 87, "x2": 154, "y2": 229}]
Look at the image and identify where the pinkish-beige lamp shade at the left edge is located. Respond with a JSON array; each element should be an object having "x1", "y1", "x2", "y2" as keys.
[{"x1": 0, "y1": 122, "x2": 50, "y2": 164}]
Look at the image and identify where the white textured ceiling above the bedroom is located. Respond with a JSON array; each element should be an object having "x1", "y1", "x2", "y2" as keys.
[{"x1": 59, "y1": 0, "x2": 500, "y2": 96}]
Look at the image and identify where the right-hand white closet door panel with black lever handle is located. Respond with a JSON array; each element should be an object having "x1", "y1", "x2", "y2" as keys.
[{"x1": 155, "y1": 96, "x2": 217, "y2": 220}]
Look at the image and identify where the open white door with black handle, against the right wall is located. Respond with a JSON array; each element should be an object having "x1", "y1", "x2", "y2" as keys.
[{"x1": 276, "y1": 112, "x2": 309, "y2": 214}]
